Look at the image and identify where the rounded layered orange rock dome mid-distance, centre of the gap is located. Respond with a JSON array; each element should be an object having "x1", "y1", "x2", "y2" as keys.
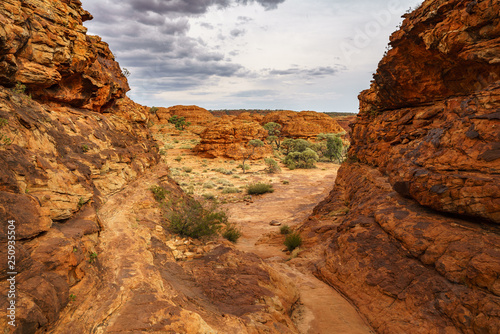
[{"x1": 193, "y1": 119, "x2": 272, "y2": 159}]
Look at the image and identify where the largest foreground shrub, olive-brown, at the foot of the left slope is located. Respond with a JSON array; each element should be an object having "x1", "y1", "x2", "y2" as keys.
[{"x1": 167, "y1": 199, "x2": 227, "y2": 239}]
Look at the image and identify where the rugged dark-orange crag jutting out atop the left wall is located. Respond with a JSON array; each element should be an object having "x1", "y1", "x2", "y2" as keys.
[{"x1": 0, "y1": 0, "x2": 129, "y2": 111}]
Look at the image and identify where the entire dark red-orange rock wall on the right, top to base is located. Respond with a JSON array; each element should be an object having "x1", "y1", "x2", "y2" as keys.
[{"x1": 303, "y1": 0, "x2": 500, "y2": 333}]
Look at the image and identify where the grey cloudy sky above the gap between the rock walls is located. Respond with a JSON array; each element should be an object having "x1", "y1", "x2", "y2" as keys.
[{"x1": 82, "y1": 0, "x2": 422, "y2": 112}]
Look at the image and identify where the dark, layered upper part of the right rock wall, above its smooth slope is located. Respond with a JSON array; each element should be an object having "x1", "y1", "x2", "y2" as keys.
[{"x1": 351, "y1": 1, "x2": 500, "y2": 223}]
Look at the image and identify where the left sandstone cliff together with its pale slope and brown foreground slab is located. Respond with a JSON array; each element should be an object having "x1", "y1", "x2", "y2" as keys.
[{"x1": 0, "y1": 0, "x2": 297, "y2": 333}]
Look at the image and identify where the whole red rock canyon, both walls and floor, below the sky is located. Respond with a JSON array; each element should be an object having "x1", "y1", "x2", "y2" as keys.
[{"x1": 0, "y1": 0, "x2": 500, "y2": 333}]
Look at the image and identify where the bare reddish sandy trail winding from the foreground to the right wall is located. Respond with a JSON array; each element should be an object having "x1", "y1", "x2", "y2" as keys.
[{"x1": 225, "y1": 165, "x2": 374, "y2": 334}]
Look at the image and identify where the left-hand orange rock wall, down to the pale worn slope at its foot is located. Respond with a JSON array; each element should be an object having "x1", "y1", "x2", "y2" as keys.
[{"x1": 0, "y1": 0, "x2": 159, "y2": 333}]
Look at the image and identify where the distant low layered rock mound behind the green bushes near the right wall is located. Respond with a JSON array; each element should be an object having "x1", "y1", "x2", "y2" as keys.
[{"x1": 261, "y1": 110, "x2": 345, "y2": 139}]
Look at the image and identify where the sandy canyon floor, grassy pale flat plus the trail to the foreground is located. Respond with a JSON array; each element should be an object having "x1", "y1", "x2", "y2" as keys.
[{"x1": 156, "y1": 127, "x2": 374, "y2": 334}]
